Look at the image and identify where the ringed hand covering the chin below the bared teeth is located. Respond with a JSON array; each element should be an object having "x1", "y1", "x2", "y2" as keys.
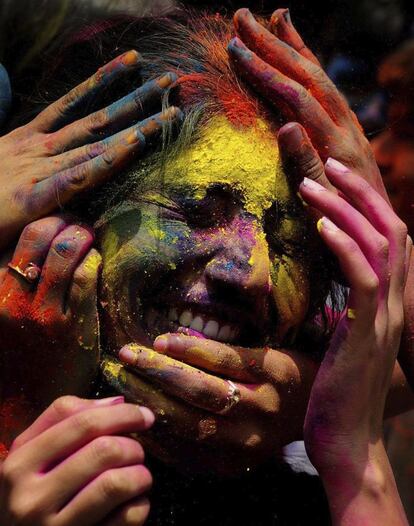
[{"x1": 103, "y1": 333, "x2": 317, "y2": 474}]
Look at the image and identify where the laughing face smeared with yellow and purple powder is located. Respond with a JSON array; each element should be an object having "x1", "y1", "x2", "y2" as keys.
[{"x1": 101, "y1": 117, "x2": 309, "y2": 349}]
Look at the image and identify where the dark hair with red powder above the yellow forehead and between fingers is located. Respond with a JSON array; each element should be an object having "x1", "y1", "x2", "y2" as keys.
[{"x1": 8, "y1": 10, "x2": 337, "y2": 349}]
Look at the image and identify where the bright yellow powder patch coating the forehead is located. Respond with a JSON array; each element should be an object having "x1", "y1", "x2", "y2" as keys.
[{"x1": 165, "y1": 116, "x2": 290, "y2": 219}]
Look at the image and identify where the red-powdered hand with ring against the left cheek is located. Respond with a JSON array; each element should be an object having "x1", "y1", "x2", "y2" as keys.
[{"x1": 0, "y1": 216, "x2": 101, "y2": 440}]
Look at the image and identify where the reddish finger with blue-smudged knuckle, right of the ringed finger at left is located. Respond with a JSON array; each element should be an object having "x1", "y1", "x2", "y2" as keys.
[{"x1": 35, "y1": 225, "x2": 94, "y2": 313}]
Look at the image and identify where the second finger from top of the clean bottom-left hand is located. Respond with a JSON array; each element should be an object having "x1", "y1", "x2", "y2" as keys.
[{"x1": 13, "y1": 404, "x2": 154, "y2": 472}]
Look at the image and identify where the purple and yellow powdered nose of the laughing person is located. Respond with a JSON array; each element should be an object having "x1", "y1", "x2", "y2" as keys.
[{"x1": 204, "y1": 217, "x2": 270, "y2": 297}]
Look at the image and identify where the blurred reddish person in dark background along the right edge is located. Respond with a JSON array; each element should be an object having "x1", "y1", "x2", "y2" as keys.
[{"x1": 371, "y1": 39, "x2": 414, "y2": 524}]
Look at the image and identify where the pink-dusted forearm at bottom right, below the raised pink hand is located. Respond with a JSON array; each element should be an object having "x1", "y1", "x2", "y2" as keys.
[{"x1": 319, "y1": 441, "x2": 408, "y2": 526}]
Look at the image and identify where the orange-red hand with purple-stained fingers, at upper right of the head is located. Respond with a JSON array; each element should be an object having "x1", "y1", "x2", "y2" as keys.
[{"x1": 228, "y1": 9, "x2": 387, "y2": 199}]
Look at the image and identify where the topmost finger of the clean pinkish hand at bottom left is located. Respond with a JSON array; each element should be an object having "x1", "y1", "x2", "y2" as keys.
[{"x1": 10, "y1": 396, "x2": 124, "y2": 452}]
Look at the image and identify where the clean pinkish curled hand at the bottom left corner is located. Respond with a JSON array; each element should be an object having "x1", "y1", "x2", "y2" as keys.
[{"x1": 0, "y1": 396, "x2": 154, "y2": 526}]
